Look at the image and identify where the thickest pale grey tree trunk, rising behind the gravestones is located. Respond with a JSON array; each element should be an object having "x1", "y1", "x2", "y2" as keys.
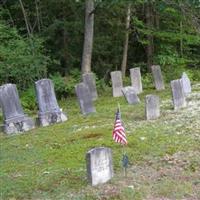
[{"x1": 81, "y1": 0, "x2": 94, "y2": 73}]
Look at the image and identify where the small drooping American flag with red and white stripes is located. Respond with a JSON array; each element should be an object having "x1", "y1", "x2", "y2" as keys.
[{"x1": 113, "y1": 109, "x2": 128, "y2": 144}]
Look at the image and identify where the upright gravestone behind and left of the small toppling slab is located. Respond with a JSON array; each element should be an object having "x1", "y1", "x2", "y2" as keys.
[{"x1": 111, "y1": 71, "x2": 123, "y2": 97}]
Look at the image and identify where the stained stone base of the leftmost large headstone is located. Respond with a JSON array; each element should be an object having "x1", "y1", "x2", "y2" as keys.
[{"x1": 3, "y1": 115, "x2": 35, "y2": 134}]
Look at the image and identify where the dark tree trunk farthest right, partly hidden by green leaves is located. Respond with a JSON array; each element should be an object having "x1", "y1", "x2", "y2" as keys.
[{"x1": 146, "y1": 1, "x2": 154, "y2": 71}]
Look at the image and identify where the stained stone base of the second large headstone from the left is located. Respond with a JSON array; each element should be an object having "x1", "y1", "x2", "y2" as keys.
[{"x1": 37, "y1": 112, "x2": 67, "y2": 126}]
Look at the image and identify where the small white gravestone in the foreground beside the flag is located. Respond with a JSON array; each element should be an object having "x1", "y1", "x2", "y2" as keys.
[{"x1": 86, "y1": 147, "x2": 113, "y2": 186}]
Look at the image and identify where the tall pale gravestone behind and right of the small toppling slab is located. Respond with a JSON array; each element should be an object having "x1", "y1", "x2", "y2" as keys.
[{"x1": 130, "y1": 67, "x2": 142, "y2": 94}]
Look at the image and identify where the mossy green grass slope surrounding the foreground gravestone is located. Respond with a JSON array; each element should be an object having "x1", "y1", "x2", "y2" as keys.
[{"x1": 0, "y1": 86, "x2": 200, "y2": 199}]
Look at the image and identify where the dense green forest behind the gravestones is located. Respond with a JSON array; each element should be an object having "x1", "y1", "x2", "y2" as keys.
[{"x1": 0, "y1": 0, "x2": 200, "y2": 98}]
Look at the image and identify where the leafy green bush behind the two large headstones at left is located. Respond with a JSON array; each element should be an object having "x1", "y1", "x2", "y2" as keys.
[{"x1": 0, "y1": 22, "x2": 48, "y2": 89}]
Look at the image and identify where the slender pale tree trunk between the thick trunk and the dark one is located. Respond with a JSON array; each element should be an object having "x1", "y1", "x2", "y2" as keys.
[{"x1": 121, "y1": 3, "x2": 131, "y2": 77}]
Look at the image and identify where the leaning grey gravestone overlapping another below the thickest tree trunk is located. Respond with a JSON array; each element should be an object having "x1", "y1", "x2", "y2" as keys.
[{"x1": 75, "y1": 83, "x2": 96, "y2": 115}]
